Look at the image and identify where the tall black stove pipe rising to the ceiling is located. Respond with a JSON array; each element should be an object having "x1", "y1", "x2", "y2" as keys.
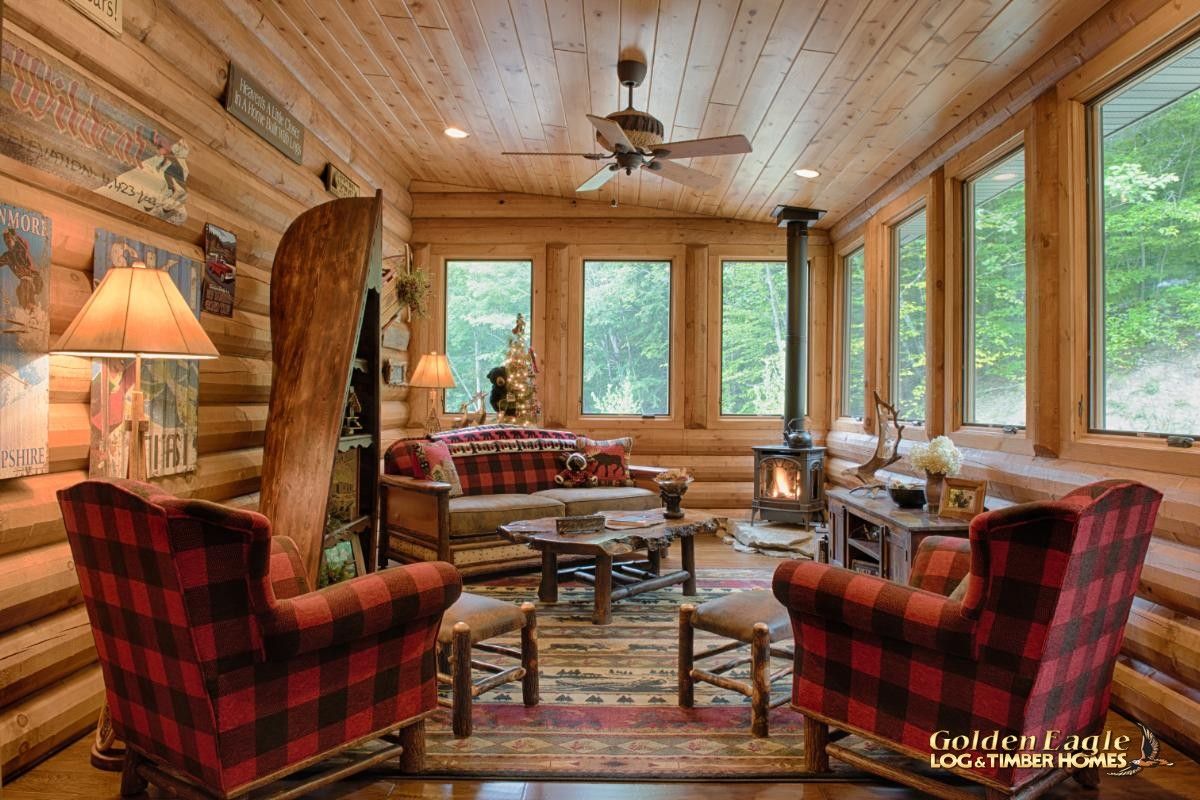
[{"x1": 772, "y1": 205, "x2": 824, "y2": 447}]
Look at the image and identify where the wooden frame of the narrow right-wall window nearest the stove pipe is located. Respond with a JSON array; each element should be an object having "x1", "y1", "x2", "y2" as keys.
[{"x1": 829, "y1": 230, "x2": 875, "y2": 433}]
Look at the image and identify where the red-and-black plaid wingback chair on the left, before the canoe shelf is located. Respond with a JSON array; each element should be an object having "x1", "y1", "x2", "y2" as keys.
[{"x1": 59, "y1": 481, "x2": 462, "y2": 798}]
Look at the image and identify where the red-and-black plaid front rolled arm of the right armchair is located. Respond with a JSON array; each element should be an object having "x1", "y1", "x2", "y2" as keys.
[{"x1": 774, "y1": 561, "x2": 974, "y2": 658}]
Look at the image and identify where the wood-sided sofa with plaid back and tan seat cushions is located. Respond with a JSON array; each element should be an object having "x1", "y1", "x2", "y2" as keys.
[{"x1": 379, "y1": 425, "x2": 661, "y2": 576}]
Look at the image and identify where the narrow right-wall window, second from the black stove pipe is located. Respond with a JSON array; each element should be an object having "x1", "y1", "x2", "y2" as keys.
[{"x1": 892, "y1": 209, "x2": 928, "y2": 421}]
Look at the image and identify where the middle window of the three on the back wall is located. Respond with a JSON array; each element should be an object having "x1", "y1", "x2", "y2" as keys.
[{"x1": 583, "y1": 261, "x2": 671, "y2": 416}]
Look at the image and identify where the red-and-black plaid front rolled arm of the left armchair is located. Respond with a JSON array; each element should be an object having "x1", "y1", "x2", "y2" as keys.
[{"x1": 263, "y1": 561, "x2": 462, "y2": 661}]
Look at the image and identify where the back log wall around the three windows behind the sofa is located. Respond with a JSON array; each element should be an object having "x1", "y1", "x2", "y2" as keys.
[{"x1": 410, "y1": 190, "x2": 832, "y2": 509}]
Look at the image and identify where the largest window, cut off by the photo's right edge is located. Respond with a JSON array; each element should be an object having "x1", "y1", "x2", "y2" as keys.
[{"x1": 1090, "y1": 39, "x2": 1200, "y2": 434}]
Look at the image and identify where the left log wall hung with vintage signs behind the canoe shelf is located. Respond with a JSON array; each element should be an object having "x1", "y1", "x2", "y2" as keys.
[{"x1": 0, "y1": 0, "x2": 412, "y2": 780}]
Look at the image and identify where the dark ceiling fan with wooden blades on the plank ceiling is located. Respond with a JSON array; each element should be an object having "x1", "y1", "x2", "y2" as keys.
[{"x1": 502, "y1": 59, "x2": 750, "y2": 192}]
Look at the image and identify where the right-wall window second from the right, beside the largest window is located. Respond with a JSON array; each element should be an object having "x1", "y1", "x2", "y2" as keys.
[{"x1": 962, "y1": 150, "x2": 1025, "y2": 427}]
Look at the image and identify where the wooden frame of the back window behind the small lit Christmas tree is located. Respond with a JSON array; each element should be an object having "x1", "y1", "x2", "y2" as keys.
[{"x1": 427, "y1": 245, "x2": 557, "y2": 427}]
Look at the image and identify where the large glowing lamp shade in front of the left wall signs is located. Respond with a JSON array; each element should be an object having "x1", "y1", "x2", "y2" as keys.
[{"x1": 54, "y1": 264, "x2": 220, "y2": 359}]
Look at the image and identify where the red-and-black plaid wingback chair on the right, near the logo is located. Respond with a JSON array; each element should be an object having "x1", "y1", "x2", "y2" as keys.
[{"x1": 774, "y1": 481, "x2": 1162, "y2": 796}]
